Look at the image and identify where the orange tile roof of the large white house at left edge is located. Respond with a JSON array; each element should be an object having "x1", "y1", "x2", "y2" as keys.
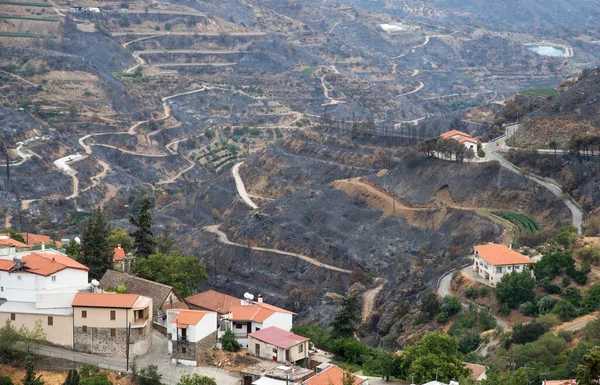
[{"x1": 0, "y1": 253, "x2": 90, "y2": 277}]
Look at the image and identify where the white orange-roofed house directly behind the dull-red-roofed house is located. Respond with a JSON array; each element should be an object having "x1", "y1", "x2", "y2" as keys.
[{"x1": 227, "y1": 294, "x2": 296, "y2": 347}]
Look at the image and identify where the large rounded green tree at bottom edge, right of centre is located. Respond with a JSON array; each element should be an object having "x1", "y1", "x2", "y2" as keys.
[{"x1": 401, "y1": 332, "x2": 469, "y2": 383}]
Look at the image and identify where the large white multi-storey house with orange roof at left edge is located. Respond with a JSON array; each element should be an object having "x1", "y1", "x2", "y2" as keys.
[{"x1": 0, "y1": 250, "x2": 90, "y2": 348}]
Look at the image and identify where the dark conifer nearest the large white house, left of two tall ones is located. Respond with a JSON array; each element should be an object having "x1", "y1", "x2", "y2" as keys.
[{"x1": 79, "y1": 207, "x2": 112, "y2": 279}]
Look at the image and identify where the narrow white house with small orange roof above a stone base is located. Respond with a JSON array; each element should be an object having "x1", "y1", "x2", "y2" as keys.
[{"x1": 167, "y1": 309, "x2": 217, "y2": 366}]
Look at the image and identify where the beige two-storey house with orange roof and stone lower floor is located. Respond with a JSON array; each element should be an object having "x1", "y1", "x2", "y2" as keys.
[{"x1": 72, "y1": 293, "x2": 152, "y2": 358}]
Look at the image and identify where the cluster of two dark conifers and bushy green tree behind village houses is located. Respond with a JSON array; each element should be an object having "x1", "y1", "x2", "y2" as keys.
[{"x1": 67, "y1": 198, "x2": 208, "y2": 296}]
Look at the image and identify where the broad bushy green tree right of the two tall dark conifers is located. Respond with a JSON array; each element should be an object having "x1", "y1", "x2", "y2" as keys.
[{"x1": 133, "y1": 251, "x2": 208, "y2": 297}]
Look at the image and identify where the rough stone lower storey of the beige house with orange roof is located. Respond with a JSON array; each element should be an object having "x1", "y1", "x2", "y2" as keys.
[{"x1": 73, "y1": 322, "x2": 152, "y2": 358}]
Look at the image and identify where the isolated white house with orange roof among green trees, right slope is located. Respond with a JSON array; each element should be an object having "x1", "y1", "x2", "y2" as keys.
[{"x1": 473, "y1": 243, "x2": 535, "y2": 286}]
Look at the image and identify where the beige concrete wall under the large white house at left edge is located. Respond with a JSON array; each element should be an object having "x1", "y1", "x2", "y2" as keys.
[{"x1": 0, "y1": 313, "x2": 73, "y2": 348}]
